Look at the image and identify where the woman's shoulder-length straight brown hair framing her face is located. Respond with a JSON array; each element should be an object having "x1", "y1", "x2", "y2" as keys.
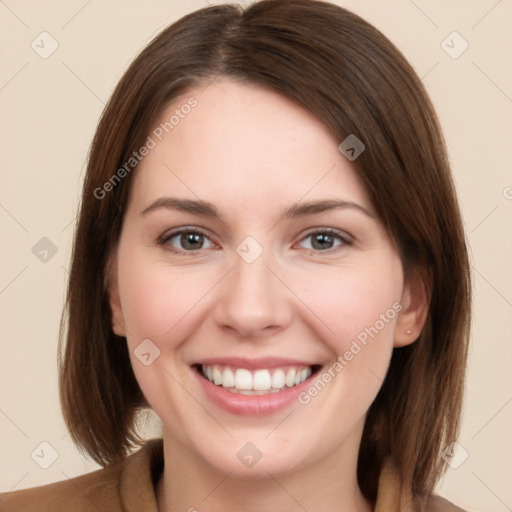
[{"x1": 59, "y1": 0, "x2": 471, "y2": 499}]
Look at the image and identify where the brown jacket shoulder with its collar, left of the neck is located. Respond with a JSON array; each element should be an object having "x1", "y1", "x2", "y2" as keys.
[{"x1": 0, "y1": 439, "x2": 163, "y2": 512}]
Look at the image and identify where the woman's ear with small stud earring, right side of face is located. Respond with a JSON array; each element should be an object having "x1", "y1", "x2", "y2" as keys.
[{"x1": 394, "y1": 271, "x2": 429, "y2": 347}]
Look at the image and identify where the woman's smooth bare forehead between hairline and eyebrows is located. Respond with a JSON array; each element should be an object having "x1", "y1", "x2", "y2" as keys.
[{"x1": 126, "y1": 79, "x2": 371, "y2": 217}]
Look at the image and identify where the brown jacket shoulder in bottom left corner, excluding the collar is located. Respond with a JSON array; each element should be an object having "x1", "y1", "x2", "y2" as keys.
[{"x1": 0, "y1": 465, "x2": 122, "y2": 512}]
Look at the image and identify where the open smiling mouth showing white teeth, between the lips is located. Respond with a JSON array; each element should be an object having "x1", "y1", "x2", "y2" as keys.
[{"x1": 194, "y1": 364, "x2": 320, "y2": 395}]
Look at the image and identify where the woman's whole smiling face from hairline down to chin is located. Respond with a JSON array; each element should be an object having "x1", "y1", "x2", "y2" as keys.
[{"x1": 110, "y1": 80, "x2": 424, "y2": 476}]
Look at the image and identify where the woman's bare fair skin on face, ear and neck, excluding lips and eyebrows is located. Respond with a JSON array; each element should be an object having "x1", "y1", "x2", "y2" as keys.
[{"x1": 109, "y1": 79, "x2": 427, "y2": 512}]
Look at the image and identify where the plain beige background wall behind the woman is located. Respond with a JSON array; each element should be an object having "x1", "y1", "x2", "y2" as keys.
[{"x1": 0, "y1": 0, "x2": 512, "y2": 512}]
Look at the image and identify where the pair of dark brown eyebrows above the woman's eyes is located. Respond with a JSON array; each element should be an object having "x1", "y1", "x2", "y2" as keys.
[{"x1": 141, "y1": 197, "x2": 375, "y2": 221}]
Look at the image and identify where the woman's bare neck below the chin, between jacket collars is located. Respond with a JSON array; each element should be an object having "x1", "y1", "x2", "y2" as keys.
[{"x1": 157, "y1": 428, "x2": 373, "y2": 512}]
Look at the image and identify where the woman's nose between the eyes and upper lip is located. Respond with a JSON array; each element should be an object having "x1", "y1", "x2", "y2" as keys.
[{"x1": 215, "y1": 247, "x2": 292, "y2": 341}]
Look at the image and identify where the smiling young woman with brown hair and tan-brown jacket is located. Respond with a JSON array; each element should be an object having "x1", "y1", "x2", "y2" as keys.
[{"x1": 0, "y1": 0, "x2": 470, "y2": 512}]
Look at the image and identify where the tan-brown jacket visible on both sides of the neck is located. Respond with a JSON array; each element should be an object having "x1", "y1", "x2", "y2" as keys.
[{"x1": 0, "y1": 439, "x2": 464, "y2": 512}]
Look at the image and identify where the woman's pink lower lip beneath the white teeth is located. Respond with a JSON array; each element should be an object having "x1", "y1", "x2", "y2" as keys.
[{"x1": 191, "y1": 368, "x2": 311, "y2": 416}]
